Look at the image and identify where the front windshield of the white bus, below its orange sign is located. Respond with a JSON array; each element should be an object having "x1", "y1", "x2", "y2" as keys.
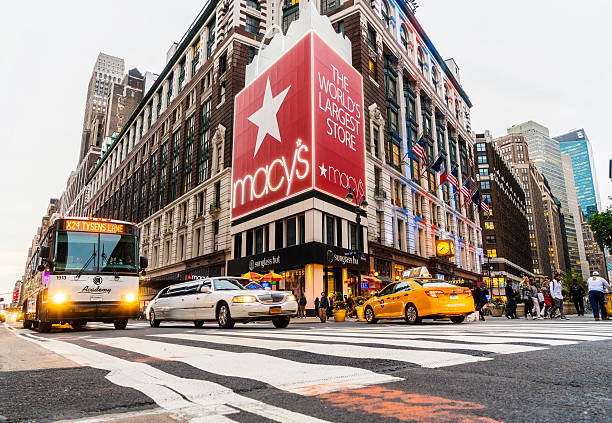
[{"x1": 53, "y1": 231, "x2": 137, "y2": 273}]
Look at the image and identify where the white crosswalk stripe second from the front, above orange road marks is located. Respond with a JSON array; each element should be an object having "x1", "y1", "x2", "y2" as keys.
[{"x1": 91, "y1": 337, "x2": 401, "y2": 395}]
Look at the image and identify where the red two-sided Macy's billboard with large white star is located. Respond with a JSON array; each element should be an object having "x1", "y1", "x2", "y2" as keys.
[{"x1": 232, "y1": 32, "x2": 365, "y2": 219}]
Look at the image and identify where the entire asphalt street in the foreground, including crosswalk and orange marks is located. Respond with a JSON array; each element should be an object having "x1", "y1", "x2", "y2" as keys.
[{"x1": 0, "y1": 317, "x2": 612, "y2": 423}]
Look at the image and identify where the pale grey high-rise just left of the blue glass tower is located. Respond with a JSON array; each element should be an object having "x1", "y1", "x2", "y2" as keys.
[{"x1": 508, "y1": 120, "x2": 585, "y2": 275}]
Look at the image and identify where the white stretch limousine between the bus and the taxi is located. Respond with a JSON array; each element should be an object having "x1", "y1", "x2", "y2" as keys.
[{"x1": 147, "y1": 276, "x2": 297, "y2": 329}]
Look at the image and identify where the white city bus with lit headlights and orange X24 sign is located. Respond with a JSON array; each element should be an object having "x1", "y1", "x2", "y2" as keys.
[{"x1": 21, "y1": 216, "x2": 147, "y2": 332}]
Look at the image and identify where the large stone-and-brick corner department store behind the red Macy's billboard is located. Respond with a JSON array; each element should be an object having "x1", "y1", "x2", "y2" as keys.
[{"x1": 81, "y1": 0, "x2": 483, "y2": 304}]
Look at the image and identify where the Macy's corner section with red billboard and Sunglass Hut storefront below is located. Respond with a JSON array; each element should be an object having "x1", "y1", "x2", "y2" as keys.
[{"x1": 227, "y1": 9, "x2": 378, "y2": 308}]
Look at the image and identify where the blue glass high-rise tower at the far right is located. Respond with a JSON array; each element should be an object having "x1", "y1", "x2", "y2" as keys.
[{"x1": 554, "y1": 129, "x2": 601, "y2": 220}]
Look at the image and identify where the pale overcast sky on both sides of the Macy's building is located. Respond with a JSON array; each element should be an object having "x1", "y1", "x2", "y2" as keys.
[{"x1": 0, "y1": 0, "x2": 612, "y2": 297}]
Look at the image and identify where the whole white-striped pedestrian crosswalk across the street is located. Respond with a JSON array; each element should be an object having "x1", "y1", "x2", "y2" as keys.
[{"x1": 18, "y1": 321, "x2": 612, "y2": 422}]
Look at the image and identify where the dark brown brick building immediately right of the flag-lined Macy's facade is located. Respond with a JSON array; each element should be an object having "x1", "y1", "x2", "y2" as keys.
[{"x1": 474, "y1": 131, "x2": 540, "y2": 295}]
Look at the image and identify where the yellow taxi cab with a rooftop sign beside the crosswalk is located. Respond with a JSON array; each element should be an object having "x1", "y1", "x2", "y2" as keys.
[{"x1": 364, "y1": 268, "x2": 475, "y2": 324}]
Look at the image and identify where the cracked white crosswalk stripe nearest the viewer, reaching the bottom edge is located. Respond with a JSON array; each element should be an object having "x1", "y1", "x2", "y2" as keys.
[{"x1": 17, "y1": 336, "x2": 324, "y2": 423}]
